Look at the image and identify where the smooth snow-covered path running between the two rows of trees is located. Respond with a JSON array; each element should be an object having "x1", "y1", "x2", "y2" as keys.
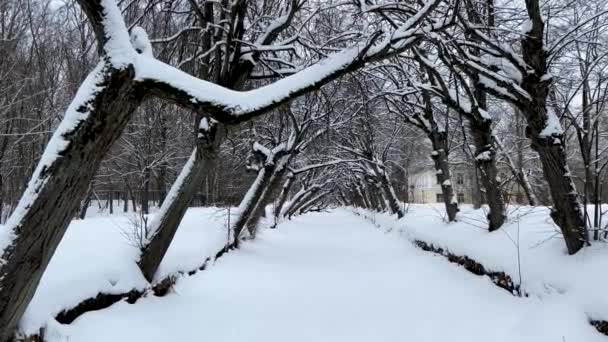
[{"x1": 48, "y1": 210, "x2": 606, "y2": 342}]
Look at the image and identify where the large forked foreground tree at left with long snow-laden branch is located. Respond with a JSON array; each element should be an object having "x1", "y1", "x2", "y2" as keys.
[{"x1": 0, "y1": 0, "x2": 444, "y2": 340}]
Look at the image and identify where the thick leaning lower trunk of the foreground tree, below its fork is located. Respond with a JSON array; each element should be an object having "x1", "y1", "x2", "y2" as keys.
[{"x1": 0, "y1": 62, "x2": 144, "y2": 341}]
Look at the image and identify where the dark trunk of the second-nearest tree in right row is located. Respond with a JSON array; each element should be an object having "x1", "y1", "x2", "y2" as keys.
[{"x1": 471, "y1": 120, "x2": 507, "y2": 231}]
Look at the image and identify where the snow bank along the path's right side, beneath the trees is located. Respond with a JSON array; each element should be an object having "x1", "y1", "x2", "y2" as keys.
[{"x1": 352, "y1": 205, "x2": 608, "y2": 330}]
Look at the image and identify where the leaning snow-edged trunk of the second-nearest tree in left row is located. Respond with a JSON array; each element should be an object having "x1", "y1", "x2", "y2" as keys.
[{"x1": 137, "y1": 117, "x2": 225, "y2": 282}]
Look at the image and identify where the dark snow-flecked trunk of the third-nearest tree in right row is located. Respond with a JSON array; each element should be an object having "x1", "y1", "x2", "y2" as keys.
[{"x1": 429, "y1": 131, "x2": 459, "y2": 222}]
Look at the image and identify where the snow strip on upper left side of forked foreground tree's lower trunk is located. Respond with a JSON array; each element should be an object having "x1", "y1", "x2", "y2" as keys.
[{"x1": 0, "y1": 62, "x2": 105, "y2": 265}]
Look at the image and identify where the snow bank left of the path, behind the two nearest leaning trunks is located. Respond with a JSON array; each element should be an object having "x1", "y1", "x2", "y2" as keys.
[{"x1": 20, "y1": 208, "x2": 226, "y2": 341}]
